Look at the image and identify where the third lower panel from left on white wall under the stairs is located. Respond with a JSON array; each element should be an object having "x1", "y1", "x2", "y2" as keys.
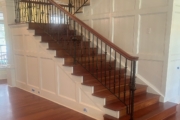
[{"x1": 41, "y1": 58, "x2": 57, "y2": 94}]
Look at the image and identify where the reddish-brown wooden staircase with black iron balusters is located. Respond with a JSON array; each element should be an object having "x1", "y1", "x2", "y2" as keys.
[{"x1": 16, "y1": 0, "x2": 176, "y2": 120}]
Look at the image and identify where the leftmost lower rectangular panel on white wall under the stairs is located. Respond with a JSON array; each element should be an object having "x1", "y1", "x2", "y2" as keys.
[{"x1": 15, "y1": 55, "x2": 27, "y2": 84}]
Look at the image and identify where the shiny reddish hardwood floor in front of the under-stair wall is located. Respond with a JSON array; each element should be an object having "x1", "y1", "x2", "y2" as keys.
[{"x1": 0, "y1": 80, "x2": 94, "y2": 120}]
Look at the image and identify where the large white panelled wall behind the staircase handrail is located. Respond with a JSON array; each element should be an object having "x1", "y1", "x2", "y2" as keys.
[{"x1": 76, "y1": 0, "x2": 173, "y2": 101}]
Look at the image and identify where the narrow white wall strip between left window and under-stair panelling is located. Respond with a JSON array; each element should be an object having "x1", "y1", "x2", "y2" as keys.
[{"x1": 1, "y1": 0, "x2": 15, "y2": 86}]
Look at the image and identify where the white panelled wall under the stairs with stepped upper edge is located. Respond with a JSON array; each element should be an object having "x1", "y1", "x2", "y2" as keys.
[{"x1": 7, "y1": 24, "x2": 122, "y2": 120}]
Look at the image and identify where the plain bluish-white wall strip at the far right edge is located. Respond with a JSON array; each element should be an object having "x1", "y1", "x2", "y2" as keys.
[{"x1": 166, "y1": 0, "x2": 180, "y2": 103}]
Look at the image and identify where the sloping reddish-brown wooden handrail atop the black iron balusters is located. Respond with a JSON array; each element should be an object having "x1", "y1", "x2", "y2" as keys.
[{"x1": 48, "y1": 0, "x2": 139, "y2": 61}]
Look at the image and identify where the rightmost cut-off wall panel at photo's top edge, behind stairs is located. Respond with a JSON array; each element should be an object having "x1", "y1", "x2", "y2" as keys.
[{"x1": 140, "y1": 0, "x2": 169, "y2": 9}]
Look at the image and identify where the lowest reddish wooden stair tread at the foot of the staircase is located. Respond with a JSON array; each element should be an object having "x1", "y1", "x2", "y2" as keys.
[{"x1": 104, "y1": 102, "x2": 177, "y2": 120}]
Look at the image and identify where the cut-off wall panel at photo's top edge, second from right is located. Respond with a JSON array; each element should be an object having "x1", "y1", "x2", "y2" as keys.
[{"x1": 113, "y1": 0, "x2": 136, "y2": 12}]
